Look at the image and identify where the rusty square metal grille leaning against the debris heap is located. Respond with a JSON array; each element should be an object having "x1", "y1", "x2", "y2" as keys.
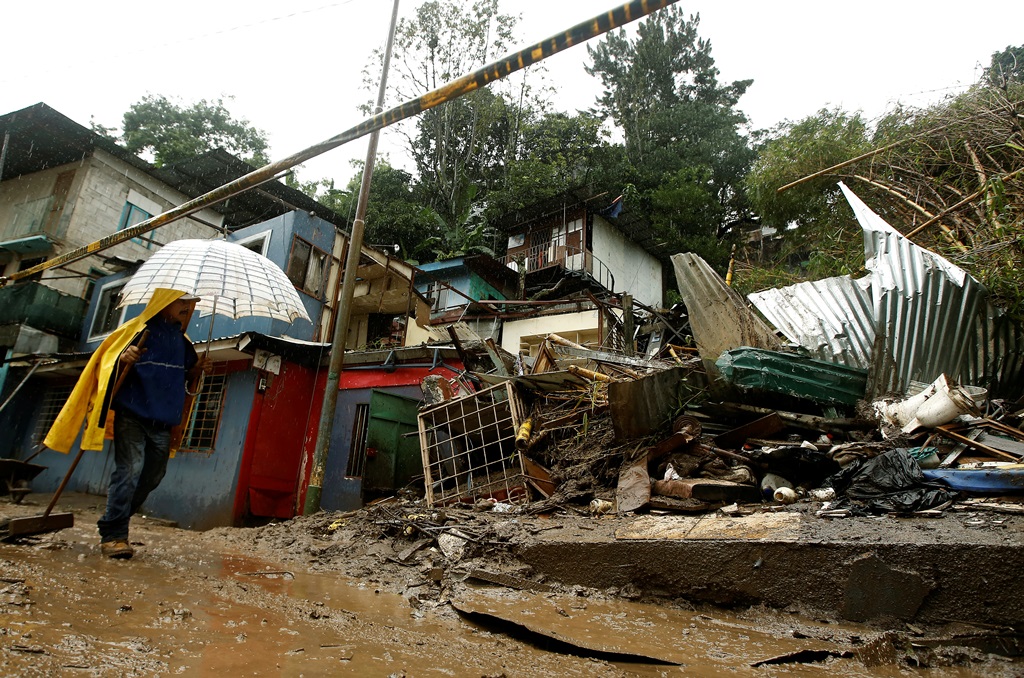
[{"x1": 419, "y1": 383, "x2": 528, "y2": 506}]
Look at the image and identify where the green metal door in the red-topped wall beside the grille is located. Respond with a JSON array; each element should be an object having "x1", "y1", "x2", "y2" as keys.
[{"x1": 362, "y1": 389, "x2": 423, "y2": 497}]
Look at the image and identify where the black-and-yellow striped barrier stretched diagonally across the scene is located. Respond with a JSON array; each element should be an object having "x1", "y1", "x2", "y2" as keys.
[{"x1": 6, "y1": 0, "x2": 678, "y2": 287}]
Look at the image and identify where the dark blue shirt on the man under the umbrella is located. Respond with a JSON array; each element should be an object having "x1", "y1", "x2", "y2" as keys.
[{"x1": 114, "y1": 315, "x2": 197, "y2": 426}]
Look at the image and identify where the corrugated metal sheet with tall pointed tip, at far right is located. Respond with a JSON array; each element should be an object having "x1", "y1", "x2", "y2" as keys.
[{"x1": 840, "y1": 183, "x2": 1024, "y2": 396}]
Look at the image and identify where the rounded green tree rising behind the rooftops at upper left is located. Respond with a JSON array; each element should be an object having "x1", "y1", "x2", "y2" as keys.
[{"x1": 122, "y1": 94, "x2": 268, "y2": 167}]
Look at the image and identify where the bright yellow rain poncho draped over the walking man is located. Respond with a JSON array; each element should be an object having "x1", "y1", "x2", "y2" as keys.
[{"x1": 43, "y1": 288, "x2": 189, "y2": 454}]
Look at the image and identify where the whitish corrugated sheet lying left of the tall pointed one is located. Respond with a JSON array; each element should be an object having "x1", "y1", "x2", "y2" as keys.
[{"x1": 746, "y1": 276, "x2": 874, "y2": 370}]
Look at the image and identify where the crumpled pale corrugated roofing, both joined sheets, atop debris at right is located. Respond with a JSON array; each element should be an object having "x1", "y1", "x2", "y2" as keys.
[{"x1": 749, "y1": 183, "x2": 1024, "y2": 398}]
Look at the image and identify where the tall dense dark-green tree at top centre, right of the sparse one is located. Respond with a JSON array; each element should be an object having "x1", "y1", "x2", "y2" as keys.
[{"x1": 587, "y1": 6, "x2": 754, "y2": 264}]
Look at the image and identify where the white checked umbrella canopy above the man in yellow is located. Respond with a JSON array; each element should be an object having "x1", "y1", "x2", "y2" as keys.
[{"x1": 121, "y1": 240, "x2": 309, "y2": 323}]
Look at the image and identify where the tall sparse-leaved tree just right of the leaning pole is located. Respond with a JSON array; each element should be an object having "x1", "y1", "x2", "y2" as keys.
[{"x1": 365, "y1": 0, "x2": 569, "y2": 259}]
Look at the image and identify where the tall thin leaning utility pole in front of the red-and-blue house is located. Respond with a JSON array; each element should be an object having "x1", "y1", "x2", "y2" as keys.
[{"x1": 302, "y1": 0, "x2": 398, "y2": 515}]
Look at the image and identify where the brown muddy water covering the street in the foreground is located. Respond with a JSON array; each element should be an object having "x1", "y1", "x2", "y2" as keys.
[{"x1": 0, "y1": 531, "x2": 999, "y2": 676}]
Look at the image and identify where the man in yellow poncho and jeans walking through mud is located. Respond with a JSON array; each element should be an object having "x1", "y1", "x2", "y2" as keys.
[{"x1": 44, "y1": 289, "x2": 210, "y2": 558}]
